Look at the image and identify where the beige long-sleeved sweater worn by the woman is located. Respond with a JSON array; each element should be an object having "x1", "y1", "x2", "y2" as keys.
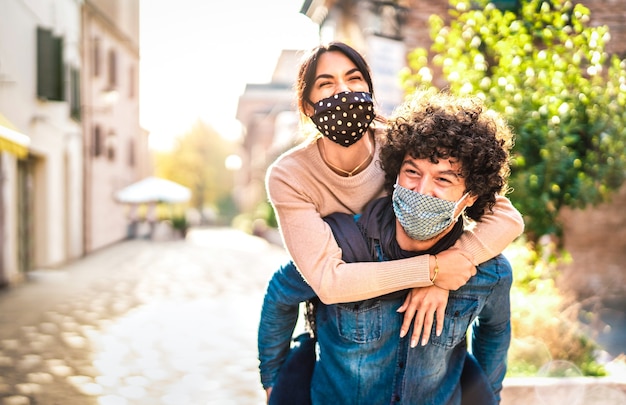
[{"x1": 266, "y1": 133, "x2": 524, "y2": 304}]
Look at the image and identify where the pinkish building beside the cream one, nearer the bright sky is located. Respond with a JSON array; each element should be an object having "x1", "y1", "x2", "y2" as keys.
[{"x1": 81, "y1": 0, "x2": 150, "y2": 253}]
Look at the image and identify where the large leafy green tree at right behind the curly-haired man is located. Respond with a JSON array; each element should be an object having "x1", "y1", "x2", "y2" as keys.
[{"x1": 402, "y1": 0, "x2": 626, "y2": 241}]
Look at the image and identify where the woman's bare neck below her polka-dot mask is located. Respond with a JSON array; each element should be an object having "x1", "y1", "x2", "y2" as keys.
[{"x1": 317, "y1": 131, "x2": 376, "y2": 177}]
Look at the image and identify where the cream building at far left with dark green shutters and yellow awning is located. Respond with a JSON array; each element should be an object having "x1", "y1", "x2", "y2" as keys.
[{"x1": 0, "y1": 0, "x2": 82, "y2": 283}]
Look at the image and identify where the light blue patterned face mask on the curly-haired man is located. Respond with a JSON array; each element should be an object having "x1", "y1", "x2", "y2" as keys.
[{"x1": 392, "y1": 184, "x2": 468, "y2": 241}]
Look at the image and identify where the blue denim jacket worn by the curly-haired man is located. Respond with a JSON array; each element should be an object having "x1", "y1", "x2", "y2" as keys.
[{"x1": 258, "y1": 197, "x2": 512, "y2": 404}]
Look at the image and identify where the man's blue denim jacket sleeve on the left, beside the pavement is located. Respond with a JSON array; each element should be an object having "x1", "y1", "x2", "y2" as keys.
[{"x1": 258, "y1": 262, "x2": 315, "y2": 388}]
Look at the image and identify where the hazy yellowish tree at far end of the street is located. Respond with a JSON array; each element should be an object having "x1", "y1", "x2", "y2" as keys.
[{"x1": 155, "y1": 120, "x2": 237, "y2": 224}]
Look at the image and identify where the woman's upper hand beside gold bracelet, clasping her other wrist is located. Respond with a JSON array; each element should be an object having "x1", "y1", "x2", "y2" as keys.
[{"x1": 431, "y1": 247, "x2": 478, "y2": 290}]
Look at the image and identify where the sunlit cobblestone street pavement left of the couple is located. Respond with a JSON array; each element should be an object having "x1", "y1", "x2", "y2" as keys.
[{"x1": 0, "y1": 229, "x2": 286, "y2": 405}]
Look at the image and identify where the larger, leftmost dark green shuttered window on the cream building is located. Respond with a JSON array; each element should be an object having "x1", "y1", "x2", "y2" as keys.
[{"x1": 37, "y1": 27, "x2": 65, "y2": 101}]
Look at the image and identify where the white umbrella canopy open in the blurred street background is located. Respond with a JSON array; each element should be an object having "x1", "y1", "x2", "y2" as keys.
[{"x1": 115, "y1": 176, "x2": 191, "y2": 204}]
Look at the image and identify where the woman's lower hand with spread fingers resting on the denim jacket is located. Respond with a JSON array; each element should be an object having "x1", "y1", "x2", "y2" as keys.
[{"x1": 398, "y1": 285, "x2": 449, "y2": 347}]
